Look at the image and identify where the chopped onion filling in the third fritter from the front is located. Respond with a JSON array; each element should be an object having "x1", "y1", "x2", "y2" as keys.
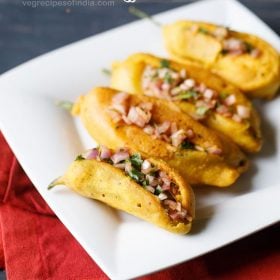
[{"x1": 142, "y1": 65, "x2": 250, "y2": 122}]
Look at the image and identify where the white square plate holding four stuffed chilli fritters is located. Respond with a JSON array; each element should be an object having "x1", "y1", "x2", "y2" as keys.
[{"x1": 0, "y1": 0, "x2": 280, "y2": 279}]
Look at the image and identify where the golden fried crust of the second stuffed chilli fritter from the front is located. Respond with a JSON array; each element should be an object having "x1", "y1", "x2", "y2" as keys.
[{"x1": 73, "y1": 88, "x2": 248, "y2": 187}]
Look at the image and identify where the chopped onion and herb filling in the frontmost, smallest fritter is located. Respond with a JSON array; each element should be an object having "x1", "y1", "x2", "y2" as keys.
[{"x1": 80, "y1": 146, "x2": 192, "y2": 222}]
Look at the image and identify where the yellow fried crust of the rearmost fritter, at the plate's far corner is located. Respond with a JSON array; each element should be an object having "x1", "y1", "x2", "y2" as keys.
[{"x1": 163, "y1": 20, "x2": 280, "y2": 99}]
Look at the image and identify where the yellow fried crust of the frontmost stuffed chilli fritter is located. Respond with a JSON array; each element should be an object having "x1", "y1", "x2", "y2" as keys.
[{"x1": 53, "y1": 159, "x2": 195, "y2": 234}]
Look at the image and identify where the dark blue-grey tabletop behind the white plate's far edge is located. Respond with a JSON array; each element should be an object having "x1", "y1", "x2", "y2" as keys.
[{"x1": 0, "y1": 0, "x2": 280, "y2": 279}]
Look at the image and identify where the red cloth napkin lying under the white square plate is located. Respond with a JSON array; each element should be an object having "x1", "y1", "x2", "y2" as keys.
[{"x1": 0, "y1": 134, "x2": 280, "y2": 280}]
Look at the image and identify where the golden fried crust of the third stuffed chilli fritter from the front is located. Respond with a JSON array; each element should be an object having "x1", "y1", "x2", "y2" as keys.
[{"x1": 111, "y1": 53, "x2": 262, "y2": 153}]
